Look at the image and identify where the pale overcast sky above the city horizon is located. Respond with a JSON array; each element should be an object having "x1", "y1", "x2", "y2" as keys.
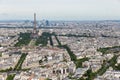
[{"x1": 0, "y1": 0, "x2": 120, "y2": 20}]
